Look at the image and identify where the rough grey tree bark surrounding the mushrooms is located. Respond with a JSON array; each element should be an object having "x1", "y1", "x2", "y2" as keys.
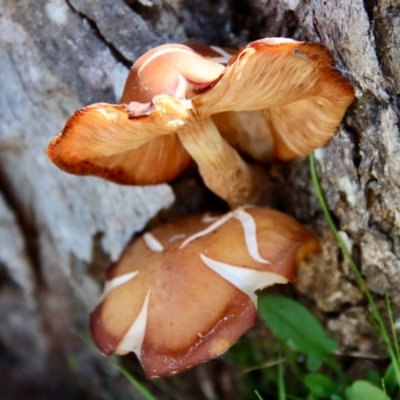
[{"x1": 0, "y1": 0, "x2": 400, "y2": 398}]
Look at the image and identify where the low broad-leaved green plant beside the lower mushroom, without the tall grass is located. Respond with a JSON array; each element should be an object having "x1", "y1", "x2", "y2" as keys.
[{"x1": 258, "y1": 295, "x2": 390, "y2": 400}]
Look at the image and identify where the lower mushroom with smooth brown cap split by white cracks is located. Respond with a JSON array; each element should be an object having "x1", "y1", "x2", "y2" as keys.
[{"x1": 90, "y1": 206, "x2": 319, "y2": 378}]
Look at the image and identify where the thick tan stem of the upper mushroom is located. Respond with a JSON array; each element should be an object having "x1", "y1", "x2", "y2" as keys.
[{"x1": 178, "y1": 118, "x2": 259, "y2": 209}]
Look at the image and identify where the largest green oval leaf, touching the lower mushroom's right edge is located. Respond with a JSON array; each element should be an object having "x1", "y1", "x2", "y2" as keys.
[{"x1": 258, "y1": 295, "x2": 337, "y2": 370}]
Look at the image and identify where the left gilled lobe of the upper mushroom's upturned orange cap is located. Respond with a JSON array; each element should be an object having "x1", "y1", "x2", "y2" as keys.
[{"x1": 47, "y1": 100, "x2": 191, "y2": 185}]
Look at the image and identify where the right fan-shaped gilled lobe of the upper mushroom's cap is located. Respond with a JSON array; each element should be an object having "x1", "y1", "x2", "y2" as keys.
[{"x1": 203, "y1": 39, "x2": 354, "y2": 162}]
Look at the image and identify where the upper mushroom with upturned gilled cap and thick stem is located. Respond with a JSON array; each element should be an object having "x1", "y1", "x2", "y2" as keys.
[{"x1": 47, "y1": 39, "x2": 354, "y2": 208}]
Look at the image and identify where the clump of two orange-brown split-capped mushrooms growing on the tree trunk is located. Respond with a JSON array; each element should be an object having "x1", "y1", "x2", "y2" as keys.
[{"x1": 47, "y1": 39, "x2": 354, "y2": 377}]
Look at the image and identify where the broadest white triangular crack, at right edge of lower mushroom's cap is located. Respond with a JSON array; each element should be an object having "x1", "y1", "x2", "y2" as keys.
[{"x1": 200, "y1": 254, "x2": 288, "y2": 307}]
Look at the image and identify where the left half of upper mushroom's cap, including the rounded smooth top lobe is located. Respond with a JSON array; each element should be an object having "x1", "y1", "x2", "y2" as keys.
[{"x1": 47, "y1": 44, "x2": 227, "y2": 185}]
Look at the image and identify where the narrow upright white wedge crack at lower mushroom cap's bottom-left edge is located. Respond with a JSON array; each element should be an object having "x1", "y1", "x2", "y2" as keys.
[{"x1": 115, "y1": 290, "x2": 150, "y2": 359}]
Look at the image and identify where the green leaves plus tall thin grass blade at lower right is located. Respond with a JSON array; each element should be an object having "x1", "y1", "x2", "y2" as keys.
[{"x1": 248, "y1": 153, "x2": 400, "y2": 400}]
